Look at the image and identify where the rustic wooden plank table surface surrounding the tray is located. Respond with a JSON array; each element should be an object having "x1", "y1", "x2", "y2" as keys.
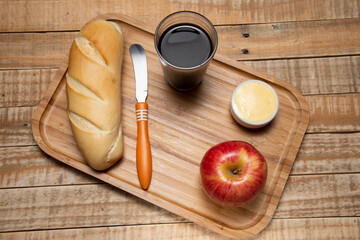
[{"x1": 0, "y1": 0, "x2": 360, "y2": 239}]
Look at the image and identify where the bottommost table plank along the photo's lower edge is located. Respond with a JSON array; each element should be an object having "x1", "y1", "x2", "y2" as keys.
[{"x1": 0, "y1": 217, "x2": 360, "y2": 240}]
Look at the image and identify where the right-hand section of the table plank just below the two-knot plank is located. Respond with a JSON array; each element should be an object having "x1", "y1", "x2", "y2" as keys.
[{"x1": 243, "y1": 56, "x2": 360, "y2": 95}]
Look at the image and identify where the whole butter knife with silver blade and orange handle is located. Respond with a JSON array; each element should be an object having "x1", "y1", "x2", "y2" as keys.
[{"x1": 129, "y1": 44, "x2": 152, "y2": 190}]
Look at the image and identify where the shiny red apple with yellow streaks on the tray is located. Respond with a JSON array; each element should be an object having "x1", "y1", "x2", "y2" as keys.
[{"x1": 200, "y1": 141, "x2": 267, "y2": 207}]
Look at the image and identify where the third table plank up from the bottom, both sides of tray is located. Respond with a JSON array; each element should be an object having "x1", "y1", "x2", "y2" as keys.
[{"x1": 0, "y1": 133, "x2": 360, "y2": 188}]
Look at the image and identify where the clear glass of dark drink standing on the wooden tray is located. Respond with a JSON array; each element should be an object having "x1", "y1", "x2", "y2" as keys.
[{"x1": 154, "y1": 11, "x2": 218, "y2": 91}]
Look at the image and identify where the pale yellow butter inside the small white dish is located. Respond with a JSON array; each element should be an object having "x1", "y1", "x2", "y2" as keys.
[{"x1": 233, "y1": 81, "x2": 278, "y2": 123}]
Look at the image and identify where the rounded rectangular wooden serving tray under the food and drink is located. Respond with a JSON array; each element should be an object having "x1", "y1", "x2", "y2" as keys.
[{"x1": 32, "y1": 14, "x2": 309, "y2": 238}]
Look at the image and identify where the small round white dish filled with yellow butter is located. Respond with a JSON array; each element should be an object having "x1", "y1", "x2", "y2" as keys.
[{"x1": 230, "y1": 80, "x2": 279, "y2": 128}]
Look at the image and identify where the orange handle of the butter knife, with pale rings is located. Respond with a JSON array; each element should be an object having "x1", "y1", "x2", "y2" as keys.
[{"x1": 136, "y1": 102, "x2": 152, "y2": 190}]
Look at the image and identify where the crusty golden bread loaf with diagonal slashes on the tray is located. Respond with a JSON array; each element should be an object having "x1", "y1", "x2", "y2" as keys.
[{"x1": 66, "y1": 20, "x2": 124, "y2": 170}]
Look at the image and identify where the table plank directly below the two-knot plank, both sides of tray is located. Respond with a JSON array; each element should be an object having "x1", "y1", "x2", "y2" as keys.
[{"x1": 0, "y1": 56, "x2": 360, "y2": 104}]
